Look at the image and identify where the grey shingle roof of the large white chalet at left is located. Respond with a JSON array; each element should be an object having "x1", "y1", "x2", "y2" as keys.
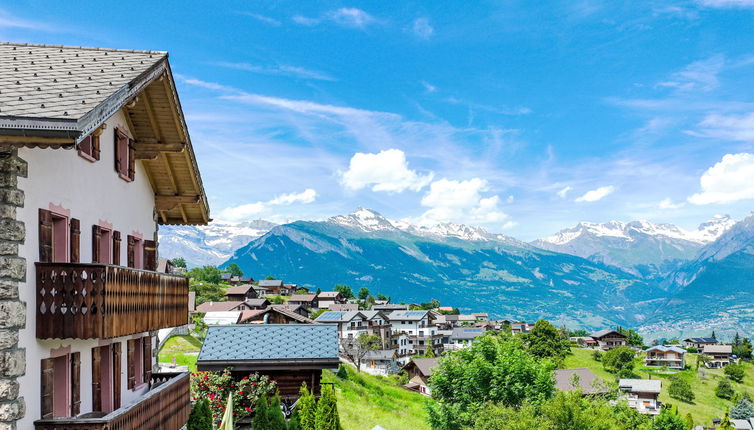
[{"x1": 0, "y1": 42, "x2": 167, "y2": 129}]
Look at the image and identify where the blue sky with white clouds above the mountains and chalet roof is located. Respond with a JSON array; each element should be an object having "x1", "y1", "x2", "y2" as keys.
[{"x1": 0, "y1": 0, "x2": 754, "y2": 240}]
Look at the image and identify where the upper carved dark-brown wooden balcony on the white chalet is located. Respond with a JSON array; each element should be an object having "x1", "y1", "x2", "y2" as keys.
[{"x1": 36, "y1": 263, "x2": 188, "y2": 339}]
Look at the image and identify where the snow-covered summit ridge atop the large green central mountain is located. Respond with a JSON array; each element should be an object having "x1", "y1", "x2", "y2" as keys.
[{"x1": 327, "y1": 208, "x2": 523, "y2": 245}]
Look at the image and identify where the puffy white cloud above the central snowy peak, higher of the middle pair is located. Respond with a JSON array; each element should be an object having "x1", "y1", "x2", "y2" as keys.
[{"x1": 341, "y1": 149, "x2": 434, "y2": 193}]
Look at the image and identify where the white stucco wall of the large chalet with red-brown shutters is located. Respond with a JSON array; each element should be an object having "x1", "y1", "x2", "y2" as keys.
[{"x1": 17, "y1": 112, "x2": 157, "y2": 429}]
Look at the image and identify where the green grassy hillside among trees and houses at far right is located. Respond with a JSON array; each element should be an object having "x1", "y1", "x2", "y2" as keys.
[{"x1": 563, "y1": 348, "x2": 754, "y2": 425}]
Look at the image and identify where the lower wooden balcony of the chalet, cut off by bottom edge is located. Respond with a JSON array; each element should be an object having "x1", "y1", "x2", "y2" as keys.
[{"x1": 34, "y1": 372, "x2": 191, "y2": 430}]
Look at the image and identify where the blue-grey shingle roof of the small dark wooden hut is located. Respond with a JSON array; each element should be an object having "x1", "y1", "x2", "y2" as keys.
[{"x1": 198, "y1": 324, "x2": 338, "y2": 362}]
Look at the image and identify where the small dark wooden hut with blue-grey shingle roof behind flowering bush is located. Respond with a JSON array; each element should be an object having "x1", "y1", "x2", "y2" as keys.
[{"x1": 196, "y1": 324, "x2": 339, "y2": 400}]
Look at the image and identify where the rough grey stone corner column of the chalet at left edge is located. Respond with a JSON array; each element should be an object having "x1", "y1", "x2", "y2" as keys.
[{"x1": 0, "y1": 145, "x2": 27, "y2": 430}]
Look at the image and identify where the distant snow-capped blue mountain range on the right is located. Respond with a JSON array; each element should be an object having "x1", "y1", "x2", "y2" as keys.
[{"x1": 532, "y1": 215, "x2": 735, "y2": 274}]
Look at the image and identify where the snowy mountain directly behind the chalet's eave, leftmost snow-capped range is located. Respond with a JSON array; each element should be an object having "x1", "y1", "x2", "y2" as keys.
[{"x1": 160, "y1": 220, "x2": 277, "y2": 266}]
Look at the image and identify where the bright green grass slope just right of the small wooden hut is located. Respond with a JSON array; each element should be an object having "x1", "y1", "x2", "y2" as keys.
[{"x1": 322, "y1": 366, "x2": 430, "y2": 430}]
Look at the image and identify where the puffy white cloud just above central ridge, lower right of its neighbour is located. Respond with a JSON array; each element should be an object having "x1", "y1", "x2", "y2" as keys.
[{"x1": 416, "y1": 178, "x2": 508, "y2": 225}]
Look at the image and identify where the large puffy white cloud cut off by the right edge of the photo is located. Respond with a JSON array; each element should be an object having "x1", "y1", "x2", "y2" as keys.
[{"x1": 688, "y1": 152, "x2": 754, "y2": 205}]
